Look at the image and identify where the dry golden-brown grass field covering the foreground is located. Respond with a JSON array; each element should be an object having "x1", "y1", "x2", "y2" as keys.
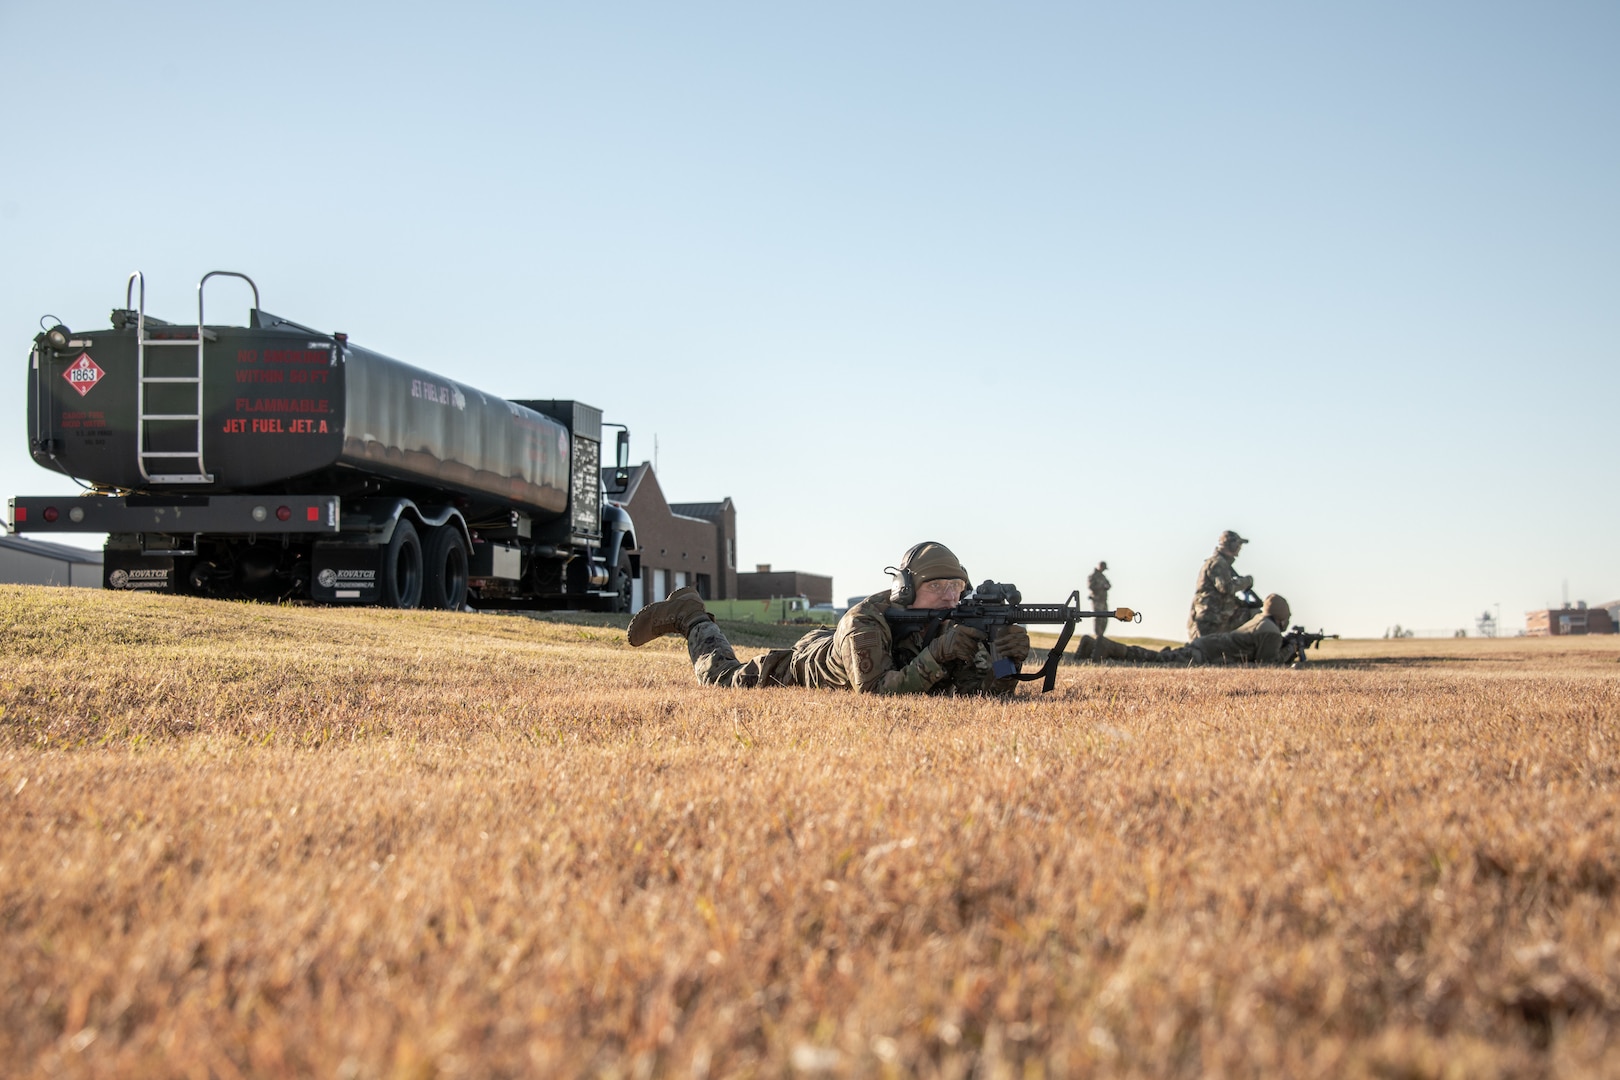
[{"x1": 0, "y1": 586, "x2": 1620, "y2": 1078}]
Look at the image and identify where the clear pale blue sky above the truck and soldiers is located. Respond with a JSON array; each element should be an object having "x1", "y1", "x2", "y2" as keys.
[{"x1": 0, "y1": 0, "x2": 1620, "y2": 636}]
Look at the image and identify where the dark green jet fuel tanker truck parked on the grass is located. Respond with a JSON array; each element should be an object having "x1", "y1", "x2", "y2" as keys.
[{"x1": 11, "y1": 270, "x2": 640, "y2": 610}]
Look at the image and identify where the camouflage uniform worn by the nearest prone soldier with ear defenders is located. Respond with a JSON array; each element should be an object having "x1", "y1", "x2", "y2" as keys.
[{"x1": 687, "y1": 589, "x2": 1024, "y2": 693}]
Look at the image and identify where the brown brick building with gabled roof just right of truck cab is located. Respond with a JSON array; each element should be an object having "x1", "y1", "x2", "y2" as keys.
[{"x1": 609, "y1": 461, "x2": 737, "y2": 610}]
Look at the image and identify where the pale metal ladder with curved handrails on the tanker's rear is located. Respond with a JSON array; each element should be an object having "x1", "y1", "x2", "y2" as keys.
[{"x1": 123, "y1": 270, "x2": 259, "y2": 484}]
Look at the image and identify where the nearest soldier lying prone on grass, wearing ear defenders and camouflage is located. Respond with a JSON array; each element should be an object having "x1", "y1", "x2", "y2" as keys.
[{"x1": 629, "y1": 541, "x2": 1029, "y2": 695}]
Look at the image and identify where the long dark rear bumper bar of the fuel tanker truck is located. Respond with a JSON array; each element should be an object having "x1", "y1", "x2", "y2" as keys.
[{"x1": 11, "y1": 495, "x2": 342, "y2": 536}]
